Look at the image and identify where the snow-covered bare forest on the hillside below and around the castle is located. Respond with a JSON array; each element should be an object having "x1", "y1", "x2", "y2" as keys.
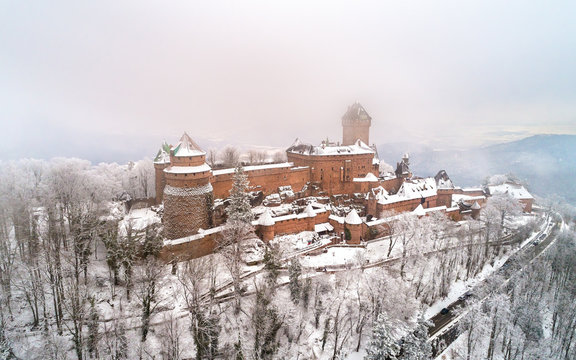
[{"x1": 0, "y1": 158, "x2": 576, "y2": 360}]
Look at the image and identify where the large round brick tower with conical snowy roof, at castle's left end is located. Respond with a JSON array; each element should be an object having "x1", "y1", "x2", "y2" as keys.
[{"x1": 163, "y1": 133, "x2": 213, "y2": 239}]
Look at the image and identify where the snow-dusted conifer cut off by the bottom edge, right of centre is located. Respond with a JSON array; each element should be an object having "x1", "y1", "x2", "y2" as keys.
[{"x1": 364, "y1": 313, "x2": 400, "y2": 360}]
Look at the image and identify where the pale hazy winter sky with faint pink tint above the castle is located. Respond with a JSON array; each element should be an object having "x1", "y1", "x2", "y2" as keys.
[{"x1": 0, "y1": 0, "x2": 576, "y2": 161}]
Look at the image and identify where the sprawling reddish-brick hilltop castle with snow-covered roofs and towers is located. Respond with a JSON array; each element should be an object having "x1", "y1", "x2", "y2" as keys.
[{"x1": 154, "y1": 103, "x2": 532, "y2": 259}]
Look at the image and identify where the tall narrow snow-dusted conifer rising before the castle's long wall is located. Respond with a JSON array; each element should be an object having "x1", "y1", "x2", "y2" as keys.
[{"x1": 226, "y1": 164, "x2": 254, "y2": 224}]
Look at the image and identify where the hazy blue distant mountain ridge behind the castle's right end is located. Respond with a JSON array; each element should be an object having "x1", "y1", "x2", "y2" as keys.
[{"x1": 378, "y1": 135, "x2": 576, "y2": 205}]
